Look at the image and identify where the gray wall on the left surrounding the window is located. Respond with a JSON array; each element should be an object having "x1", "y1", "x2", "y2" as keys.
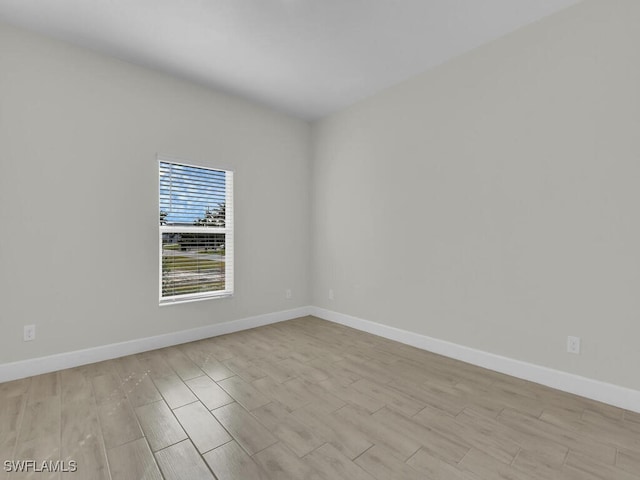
[{"x1": 0, "y1": 20, "x2": 310, "y2": 363}]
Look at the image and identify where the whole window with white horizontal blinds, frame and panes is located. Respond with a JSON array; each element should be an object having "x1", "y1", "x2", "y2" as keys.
[{"x1": 159, "y1": 159, "x2": 233, "y2": 304}]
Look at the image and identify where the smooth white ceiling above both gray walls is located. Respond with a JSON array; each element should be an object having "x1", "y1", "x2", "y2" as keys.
[{"x1": 0, "y1": 0, "x2": 580, "y2": 119}]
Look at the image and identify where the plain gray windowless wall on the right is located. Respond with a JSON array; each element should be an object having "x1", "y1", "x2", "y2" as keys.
[{"x1": 312, "y1": 0, "x2": 640, "y2": 389}]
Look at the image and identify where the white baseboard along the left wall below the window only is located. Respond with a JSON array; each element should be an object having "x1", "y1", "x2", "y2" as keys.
[{"x1": 0, "y1": 307, "x2": 310, "y2": 382}]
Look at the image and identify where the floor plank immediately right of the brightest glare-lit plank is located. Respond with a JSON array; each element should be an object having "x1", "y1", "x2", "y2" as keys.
[{"x1": 212, "y1": 403, "x2": 278, "y2": 455}]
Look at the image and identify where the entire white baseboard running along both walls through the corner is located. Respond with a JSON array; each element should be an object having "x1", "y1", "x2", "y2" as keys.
[{"x1": 5, "y1": 306, "x2": 640, "y2": 413}]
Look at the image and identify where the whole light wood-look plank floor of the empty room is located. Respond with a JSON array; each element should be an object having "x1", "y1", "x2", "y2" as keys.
[{"x1": 0, "y1": 317, "x2": 640, "y2": 480}]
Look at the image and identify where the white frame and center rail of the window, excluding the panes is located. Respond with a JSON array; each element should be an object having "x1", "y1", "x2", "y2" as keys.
[{"x1": 157, "y1": 155, "x2": 234, "y2": 306}]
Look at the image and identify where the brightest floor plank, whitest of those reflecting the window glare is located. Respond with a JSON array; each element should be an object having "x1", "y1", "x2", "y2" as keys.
[{"x1": 173, "y1": 402, "x2": 231, "y2": 453}]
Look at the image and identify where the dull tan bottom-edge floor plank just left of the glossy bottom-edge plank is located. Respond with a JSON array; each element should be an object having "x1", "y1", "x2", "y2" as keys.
[{"x1": 107, "y1": 438, "x2": 163, "y2": 480}]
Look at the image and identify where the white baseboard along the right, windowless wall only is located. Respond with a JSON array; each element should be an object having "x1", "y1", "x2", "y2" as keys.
[{"x1": 310, "y1": 307, "x2": 640, "y2": 413}]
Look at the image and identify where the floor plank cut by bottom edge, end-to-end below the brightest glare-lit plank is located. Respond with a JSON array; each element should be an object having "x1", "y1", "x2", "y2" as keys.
[{"x1": 204, "y1": 441, "x2": 269, "y2": 480}]
